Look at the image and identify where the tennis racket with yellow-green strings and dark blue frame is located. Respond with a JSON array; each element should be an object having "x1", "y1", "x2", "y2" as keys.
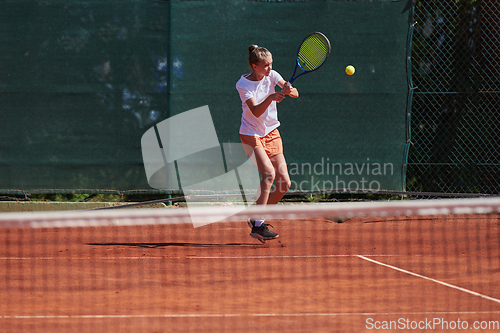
[{"x1": 288, "y1": 32, "x2": 331, "y2": 83}]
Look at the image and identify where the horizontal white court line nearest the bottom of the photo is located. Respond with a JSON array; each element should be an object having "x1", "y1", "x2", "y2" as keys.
[{"x1": 0, "y1": 311, "x2": 500, "y2": 319}]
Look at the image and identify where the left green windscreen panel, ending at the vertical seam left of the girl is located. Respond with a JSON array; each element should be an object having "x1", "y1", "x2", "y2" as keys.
[{"x1": 0, "y1": 0, "x2": 170, "y2": 193}]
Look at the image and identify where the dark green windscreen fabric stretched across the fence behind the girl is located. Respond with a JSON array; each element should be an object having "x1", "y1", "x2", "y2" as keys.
[{"x1": 0, "y1": 0, "x2": 410, "y2": 192}]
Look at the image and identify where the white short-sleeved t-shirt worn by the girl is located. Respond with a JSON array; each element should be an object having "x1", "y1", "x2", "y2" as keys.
[{"x1": 236, "y1": 70, "x2": 283, "y2": 137}]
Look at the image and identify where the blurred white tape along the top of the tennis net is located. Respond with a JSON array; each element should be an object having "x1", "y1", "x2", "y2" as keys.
[{"x1": 0, "y1": 197, "x2": 500, "y2": 228}]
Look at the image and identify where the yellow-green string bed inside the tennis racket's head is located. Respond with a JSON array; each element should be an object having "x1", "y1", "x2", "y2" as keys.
[{"x1": 297, "y1": 34, "x2": 330, "y2": 71}]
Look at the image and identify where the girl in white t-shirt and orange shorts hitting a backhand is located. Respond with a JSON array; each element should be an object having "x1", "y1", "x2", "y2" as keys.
[{"x1": 236, "y1": 45, "x2": 299, "y2": 243}]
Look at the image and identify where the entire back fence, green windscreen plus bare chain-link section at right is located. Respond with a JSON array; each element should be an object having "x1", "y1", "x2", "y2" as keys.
[{"x1": 0, "y1": 0, "x2": 500, "y2": 193}]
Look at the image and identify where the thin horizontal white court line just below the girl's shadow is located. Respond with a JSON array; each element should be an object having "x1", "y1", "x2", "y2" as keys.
[{"x1": 0, "y1": 254, "x2": 400, "y2": 260}]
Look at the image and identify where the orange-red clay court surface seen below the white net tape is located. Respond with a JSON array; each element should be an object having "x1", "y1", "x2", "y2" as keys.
[{"x1": 0, "y1": 214, "x2": 500, "y2": 333}]
